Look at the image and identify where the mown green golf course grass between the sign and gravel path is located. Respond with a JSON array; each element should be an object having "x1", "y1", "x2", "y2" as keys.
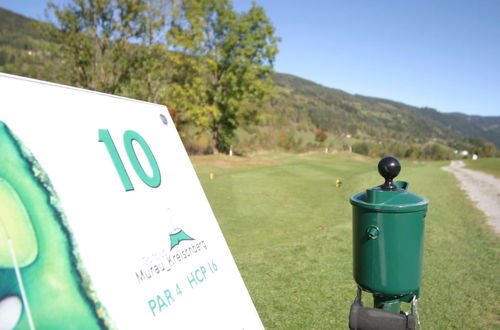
[{"x1": 193, "y1": 153, "x2": 500, "y2": 329}]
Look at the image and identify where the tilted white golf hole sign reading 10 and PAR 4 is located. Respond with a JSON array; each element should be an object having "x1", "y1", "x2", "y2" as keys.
[{"x1": 0, "y1": 74, "x2": 262, "y2": 329}]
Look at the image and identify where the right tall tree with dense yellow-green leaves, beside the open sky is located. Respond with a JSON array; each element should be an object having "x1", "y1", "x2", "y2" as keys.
[{"x1": 170, "y1": 0, "x2": 279, "y2": 152}]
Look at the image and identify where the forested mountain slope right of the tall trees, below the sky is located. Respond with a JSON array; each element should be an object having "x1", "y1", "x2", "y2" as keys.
[{"x1": 273, "y1": 73, "x2": 500, "y2": 148}]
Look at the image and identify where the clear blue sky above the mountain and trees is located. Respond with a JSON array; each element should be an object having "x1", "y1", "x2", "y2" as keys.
[{"x1": 0, "y1": 0, "x2": 500, "y2": 116}]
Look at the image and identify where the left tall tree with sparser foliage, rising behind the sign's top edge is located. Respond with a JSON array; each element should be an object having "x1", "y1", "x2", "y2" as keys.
[{"x1": 47, "y1": 0, "x2": 164, "y2": 94}]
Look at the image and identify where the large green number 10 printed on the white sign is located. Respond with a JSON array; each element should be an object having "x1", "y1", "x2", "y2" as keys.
[{"x1": 99, "y1": 129, "x2": 161, "y2": 191}]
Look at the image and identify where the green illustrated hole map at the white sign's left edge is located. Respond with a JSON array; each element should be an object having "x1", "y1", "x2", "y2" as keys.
[{"x1": 0, "y1": 121, "x2": 110, "y2": 329}]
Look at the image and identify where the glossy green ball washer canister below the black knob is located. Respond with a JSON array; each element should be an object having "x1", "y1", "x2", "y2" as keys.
[{"x1": 350, "y1": 181, "x2": 429, "y2": 299}]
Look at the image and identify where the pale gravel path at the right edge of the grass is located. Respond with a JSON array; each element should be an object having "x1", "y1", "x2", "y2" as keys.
[{"x1": 441, "y1": 160, "x2": 500, "y2": 235}]
